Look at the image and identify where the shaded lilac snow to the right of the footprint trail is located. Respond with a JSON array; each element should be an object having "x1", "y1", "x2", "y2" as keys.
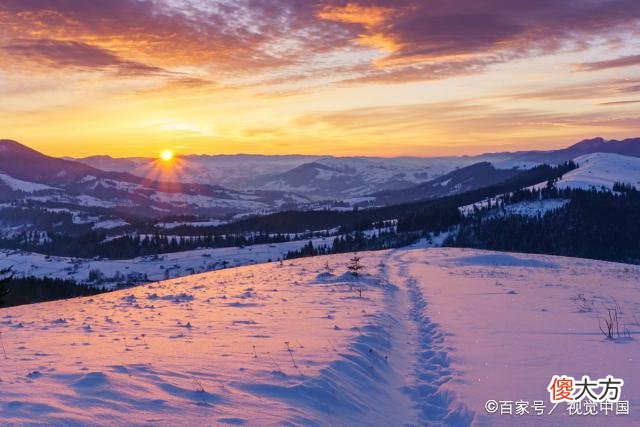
[{"x1": 393, "y1": 249, "x2": 640, "y2": 426}]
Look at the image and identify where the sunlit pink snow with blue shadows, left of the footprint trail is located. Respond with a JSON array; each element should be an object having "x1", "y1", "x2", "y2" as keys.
[{"x1": 0, "y1": 252, "x2": 410, "y2": 425}]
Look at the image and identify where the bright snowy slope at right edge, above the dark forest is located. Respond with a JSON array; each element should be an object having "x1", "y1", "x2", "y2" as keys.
[{"x1": 556, "y1": 153, "x2": 640, "y2": 190}]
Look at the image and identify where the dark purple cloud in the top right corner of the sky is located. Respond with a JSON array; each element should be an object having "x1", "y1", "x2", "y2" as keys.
[{"x1": 342, "y1": 0, "x2": 640, "y2": 59}]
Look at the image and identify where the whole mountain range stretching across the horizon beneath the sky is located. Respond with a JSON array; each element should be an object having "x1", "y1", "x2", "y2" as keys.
[{"x1": 0, "y1": 138, "x2": 640, "y2": 227}]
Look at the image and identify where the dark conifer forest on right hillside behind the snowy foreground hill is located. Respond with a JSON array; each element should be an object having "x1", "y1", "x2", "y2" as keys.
[{"x1": 445, "y1": 184, "x2": 640, "y2": 264}]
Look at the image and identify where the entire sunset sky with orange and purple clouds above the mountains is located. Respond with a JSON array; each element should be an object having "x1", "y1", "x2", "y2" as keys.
[{"x1": 0, "y1": 0, "x2": 640, "y2": 157}]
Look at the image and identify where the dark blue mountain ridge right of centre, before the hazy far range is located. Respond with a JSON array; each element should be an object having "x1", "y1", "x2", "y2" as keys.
[{"x1": 371, "y1": 162, "x2": 522, "y2": 205}]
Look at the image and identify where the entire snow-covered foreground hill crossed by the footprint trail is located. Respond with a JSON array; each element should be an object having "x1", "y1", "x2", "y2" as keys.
[{"x1": 0, "y1": 248, "x2": 640, "y2": 426}]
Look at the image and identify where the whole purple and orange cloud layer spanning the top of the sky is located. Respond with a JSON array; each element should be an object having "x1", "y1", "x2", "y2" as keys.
[{"x1": 0, "y1": 0, "x2": 640, "y2": 83}]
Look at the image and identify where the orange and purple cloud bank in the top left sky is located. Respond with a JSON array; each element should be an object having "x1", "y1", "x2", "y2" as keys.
[{"x1": 0, "y1": 0, "x2": 349, "y2": 72}]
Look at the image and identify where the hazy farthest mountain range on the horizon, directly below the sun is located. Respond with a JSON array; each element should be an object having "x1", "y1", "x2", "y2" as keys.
[{"x1": 77, "y1": 154, "x2": 492, "y2": 200}]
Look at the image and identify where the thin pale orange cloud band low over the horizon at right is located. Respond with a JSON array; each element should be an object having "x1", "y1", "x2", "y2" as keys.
[{"x1": 295, "y1": 102, "x2": 640, "y2": 142}]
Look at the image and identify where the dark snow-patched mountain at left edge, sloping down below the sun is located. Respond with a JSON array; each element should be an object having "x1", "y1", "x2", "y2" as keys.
[{"x1": 0, "y1": 140, "x2": 307, "y2": 216}]
